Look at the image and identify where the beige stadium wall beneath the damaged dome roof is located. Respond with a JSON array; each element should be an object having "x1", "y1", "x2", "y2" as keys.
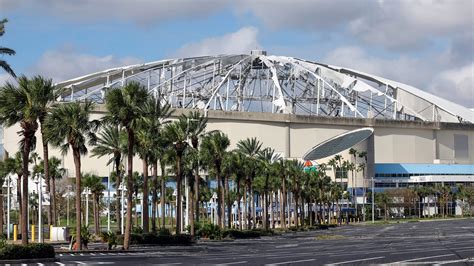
[{"x1": 3, "y1": 107, "x2": 474, "y2": 179}]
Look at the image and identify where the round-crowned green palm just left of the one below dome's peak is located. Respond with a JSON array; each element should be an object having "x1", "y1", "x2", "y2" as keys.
[{"x1": 201, "y1": 131, "x2": 230, "y2": 227}]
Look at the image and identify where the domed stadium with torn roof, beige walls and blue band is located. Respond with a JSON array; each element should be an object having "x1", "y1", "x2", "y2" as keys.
[{"x1": 0, "y1": 50, "x2": 474, "y2": 204}]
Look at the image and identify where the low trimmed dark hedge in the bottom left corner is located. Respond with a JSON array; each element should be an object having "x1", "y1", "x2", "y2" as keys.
[{"x1": 0, "y1": 243, "x2": 56, "y2": 260}]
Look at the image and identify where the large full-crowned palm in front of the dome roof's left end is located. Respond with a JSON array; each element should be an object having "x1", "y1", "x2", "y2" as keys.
[{"x1": 44, "y1": 102, "x2": 100, "y2": 249}]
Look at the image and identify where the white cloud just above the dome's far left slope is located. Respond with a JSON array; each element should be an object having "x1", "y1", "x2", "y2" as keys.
[{"x1": 28, "y1": 47, "x2": 141, "y2": 82}]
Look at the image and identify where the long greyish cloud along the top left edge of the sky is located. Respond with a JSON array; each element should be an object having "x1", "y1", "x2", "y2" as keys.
[{"x1": 0, "y1": 0, "x2": 227, "y2": 24}]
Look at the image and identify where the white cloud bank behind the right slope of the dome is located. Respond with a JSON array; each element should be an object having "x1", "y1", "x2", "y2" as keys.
[{"x1": 322, "y1": 46, "x2": 474, "y2": 107}]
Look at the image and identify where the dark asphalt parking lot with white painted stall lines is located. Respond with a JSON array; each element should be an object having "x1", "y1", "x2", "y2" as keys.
[{"x1": 15, "y1": 219, "x2": 474, "y2": 265}]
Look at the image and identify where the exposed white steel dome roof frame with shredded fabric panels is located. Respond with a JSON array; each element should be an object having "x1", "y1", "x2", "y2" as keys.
[{"x1": 56, "y1": 50, "x2": 474, "y2": 123}]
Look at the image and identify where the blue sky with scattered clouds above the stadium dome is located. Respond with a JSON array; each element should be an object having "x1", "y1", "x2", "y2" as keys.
[{"x1": 0, "y1": 0, "x2": 474, "y2": 108}]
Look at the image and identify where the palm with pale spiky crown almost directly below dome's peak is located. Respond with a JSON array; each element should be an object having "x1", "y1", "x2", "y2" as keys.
[{"x1": 237, "y1": 138, "x2": 262, "y2": 229}]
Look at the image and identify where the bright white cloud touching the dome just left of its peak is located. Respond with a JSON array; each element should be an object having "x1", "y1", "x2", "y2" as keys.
[{"x1": 174, "y1": 27, "x2": 260, "y2": 57}]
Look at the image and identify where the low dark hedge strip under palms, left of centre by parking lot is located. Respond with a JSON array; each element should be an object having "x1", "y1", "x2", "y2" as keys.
[{"x1": 117, "y1": 233, "x2": 193, "y2": 246}]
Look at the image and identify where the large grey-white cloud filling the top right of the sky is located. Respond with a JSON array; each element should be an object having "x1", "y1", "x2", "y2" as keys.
[{"x1": 236, "y1": 0, "x2": 474, "y2": 50}]
